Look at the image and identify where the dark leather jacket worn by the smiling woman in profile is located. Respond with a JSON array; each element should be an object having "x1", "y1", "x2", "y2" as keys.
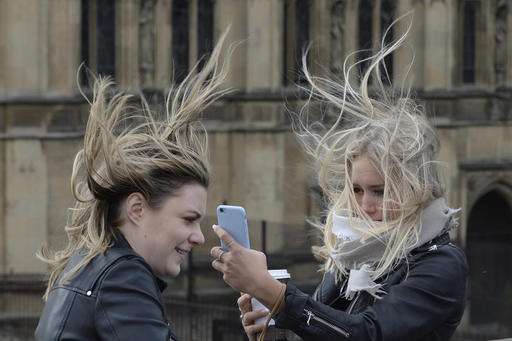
[{"x1": 35, "y1": 237, "x2": 176, "y2": 341}]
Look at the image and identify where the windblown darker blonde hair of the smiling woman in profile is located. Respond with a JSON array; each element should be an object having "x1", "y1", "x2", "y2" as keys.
[{"x1": 37, "y1": 34, "x2": 232, "y2": 299}]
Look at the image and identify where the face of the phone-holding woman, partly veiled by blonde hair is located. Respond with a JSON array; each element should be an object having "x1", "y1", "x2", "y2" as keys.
[{"x1": 351, "y1": 156, "x2": 384, "y2": 221}]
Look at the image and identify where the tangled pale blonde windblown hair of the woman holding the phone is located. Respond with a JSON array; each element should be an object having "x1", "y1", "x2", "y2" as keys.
[{"x1": 294, "y1": 21, "x2": 444, "y2": 279}]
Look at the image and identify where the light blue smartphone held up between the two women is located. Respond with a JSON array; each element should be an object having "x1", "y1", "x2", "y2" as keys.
[{"x1": 217, "y1": 205, "x2": 251, "y2": 251}]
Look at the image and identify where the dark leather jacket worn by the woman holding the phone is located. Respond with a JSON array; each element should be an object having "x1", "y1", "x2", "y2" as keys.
[{"x1": 276, "y1": 233, "x2": 468, "y2": 341}]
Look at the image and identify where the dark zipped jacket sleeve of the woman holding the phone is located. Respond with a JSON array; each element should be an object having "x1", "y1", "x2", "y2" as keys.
[{"x1": 276, "y1": 245, "x2": 468, "y2": 341}]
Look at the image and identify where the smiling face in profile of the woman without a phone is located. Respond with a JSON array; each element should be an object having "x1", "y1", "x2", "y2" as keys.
[{"x1": 121, "y1": 184, "x2": 206, "y2": 277}]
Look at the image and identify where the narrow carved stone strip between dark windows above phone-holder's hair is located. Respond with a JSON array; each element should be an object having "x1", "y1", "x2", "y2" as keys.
[{"x1": 330, "y1": 0, "x2": 345, "y2": 77}]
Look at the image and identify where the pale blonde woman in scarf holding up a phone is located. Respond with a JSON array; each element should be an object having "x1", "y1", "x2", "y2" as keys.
[{"x1": 211, "y1": 25, "x2": 468, "y2": 341}]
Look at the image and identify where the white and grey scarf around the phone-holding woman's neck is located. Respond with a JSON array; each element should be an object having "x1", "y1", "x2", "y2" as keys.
[{"x1": 331, "y1": 198, "x2": 460, "y2": 300}]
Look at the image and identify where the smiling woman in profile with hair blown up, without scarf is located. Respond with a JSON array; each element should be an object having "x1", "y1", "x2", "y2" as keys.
[{"x1": 35, "y1": 35, "x2": 231, "y2": 341}]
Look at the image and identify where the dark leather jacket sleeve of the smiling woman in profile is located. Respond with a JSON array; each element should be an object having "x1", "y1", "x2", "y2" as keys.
[{"x1": 95, "y1": 259, "x2": 172, "y2": 341}]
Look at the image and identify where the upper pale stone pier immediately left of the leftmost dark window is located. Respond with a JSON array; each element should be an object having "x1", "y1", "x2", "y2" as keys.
[{"x1": 48, "y1": 0, "x2": 81, "y2": 95}]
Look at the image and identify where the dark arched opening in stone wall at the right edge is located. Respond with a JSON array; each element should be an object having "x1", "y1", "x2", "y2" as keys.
[{"x1": 466, "y1": 190, "x2": 512, "y2": 330}]
